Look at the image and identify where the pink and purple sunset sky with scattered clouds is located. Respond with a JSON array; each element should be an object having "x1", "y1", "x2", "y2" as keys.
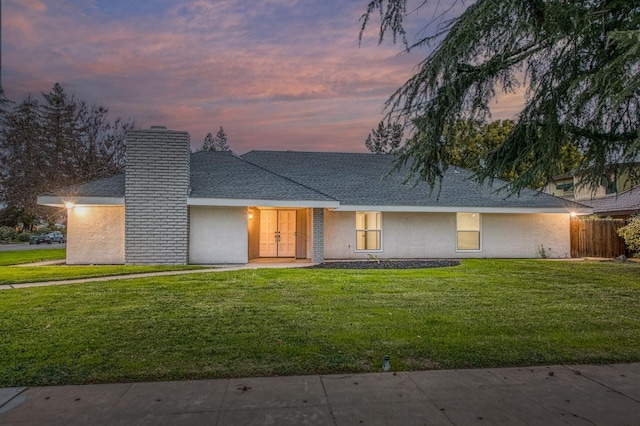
[{"x1": 2, "y1": 0, "x2": 518, "y2": 154}]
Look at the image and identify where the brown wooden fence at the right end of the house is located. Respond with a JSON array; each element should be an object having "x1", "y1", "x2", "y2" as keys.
[{"x1": 571, "y1": 217, "x2": 626, "y2": 258}]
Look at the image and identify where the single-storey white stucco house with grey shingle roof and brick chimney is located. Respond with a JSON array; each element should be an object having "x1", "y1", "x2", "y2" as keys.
[{"x1": 38, "y1": 128, "x2": 591, "y2": 264}]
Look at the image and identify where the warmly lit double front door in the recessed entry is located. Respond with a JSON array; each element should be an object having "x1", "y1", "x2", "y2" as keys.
[{"x1": 260, "y1": 210, "x2": 296, "y2": 257}]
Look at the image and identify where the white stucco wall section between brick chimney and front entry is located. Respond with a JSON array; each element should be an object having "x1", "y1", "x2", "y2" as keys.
[{"x1": 189, "y1": 206, "x2": 248, "y2": 264}]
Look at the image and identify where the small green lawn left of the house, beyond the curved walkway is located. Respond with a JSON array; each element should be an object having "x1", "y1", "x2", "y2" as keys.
[{"x1": 0, "y1": 248, "x2": 202, "y2": 285}]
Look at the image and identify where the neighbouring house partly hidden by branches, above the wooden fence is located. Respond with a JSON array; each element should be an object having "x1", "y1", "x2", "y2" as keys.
[{"x1": 543, "y1": 164, "x2": 640, "y2": 218}]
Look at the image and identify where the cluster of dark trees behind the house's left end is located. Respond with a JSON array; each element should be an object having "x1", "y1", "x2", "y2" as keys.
[{"x1": 0, "y1": 84, "x2": 135, "y2": 227}]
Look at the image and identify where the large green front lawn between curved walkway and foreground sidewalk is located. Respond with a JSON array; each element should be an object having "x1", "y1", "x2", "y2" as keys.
[{"x1": 0, "y1": 260, "x2": 640, "y2": 386}]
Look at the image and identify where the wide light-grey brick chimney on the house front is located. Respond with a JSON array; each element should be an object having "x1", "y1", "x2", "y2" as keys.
[{"x1": 125, "y1": 126, "x2": 191, "y2": 265}]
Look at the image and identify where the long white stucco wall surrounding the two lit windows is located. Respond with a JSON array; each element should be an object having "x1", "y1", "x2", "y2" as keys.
[{"x1": 325, "y1": 211, "x2": 571, "y2": 259}]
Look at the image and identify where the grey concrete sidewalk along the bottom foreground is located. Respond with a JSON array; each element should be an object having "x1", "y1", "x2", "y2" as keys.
[{"x1": 0, "y1": 363, "x2": 640, "y2": 426}]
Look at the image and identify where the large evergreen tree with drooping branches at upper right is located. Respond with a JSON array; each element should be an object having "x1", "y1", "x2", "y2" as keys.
[{"x1": 361, "y1": 0, "x2": 640, "y2": 192}]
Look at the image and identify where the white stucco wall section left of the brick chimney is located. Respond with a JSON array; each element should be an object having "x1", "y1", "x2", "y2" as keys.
[{"x1": 67, "y1": 206, "x2": 124, "y2": 265}]
